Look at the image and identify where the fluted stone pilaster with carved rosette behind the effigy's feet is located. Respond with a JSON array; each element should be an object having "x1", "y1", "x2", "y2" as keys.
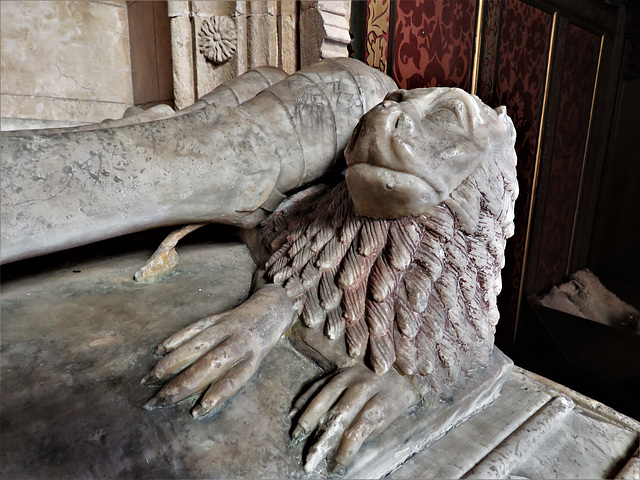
[{"x1": 169, "y1": 0, "x2": 351, "y2": 108}]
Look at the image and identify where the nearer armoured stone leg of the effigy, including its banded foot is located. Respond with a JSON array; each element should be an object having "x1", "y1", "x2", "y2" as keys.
[{"x1": 0, "y1": 59, "x2": 394, "y2": 263}]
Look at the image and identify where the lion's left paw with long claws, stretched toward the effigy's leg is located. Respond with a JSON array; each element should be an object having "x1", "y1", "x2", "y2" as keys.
[{"x1": 142, "y1": 285, "x2": 293, "y2": 417}]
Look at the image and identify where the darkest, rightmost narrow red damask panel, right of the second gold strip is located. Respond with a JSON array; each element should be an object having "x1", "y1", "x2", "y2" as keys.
[{"x1": 535, "y1": 25, "x2": 600, "y2": 293}]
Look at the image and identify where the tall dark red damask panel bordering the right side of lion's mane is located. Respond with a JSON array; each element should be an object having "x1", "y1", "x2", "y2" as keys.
[{"x1": 495, "y1": 0, "x2": 552, "y2": 344}]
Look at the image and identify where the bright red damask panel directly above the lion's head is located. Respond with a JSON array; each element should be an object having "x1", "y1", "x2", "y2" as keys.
[{"x1": 393, "y1": 0, "x2": 476, "y2": 90}]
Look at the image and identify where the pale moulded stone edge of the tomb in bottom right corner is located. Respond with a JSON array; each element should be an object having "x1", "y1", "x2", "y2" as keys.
[{"x1": 390, "y1": 367, "x2": 640, "y2": 480}]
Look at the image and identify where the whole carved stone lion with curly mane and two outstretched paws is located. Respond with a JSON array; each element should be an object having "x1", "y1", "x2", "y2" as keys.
[{"x1": 144, "y1": 88, "x2": 518, "y2": 471}]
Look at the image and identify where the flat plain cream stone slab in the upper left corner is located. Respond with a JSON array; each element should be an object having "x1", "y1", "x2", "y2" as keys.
[{"x1": 0, "y1": 0, "x2": 133, "y2": 122}]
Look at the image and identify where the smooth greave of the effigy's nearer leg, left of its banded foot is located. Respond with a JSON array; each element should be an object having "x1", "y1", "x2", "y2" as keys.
[{"x1": 0, "y1": 107, "x2": 280, "y2": 262}]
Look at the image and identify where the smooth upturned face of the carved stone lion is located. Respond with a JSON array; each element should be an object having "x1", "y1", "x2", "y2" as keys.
[{"x1": 345, "y1": 88, "x2": 510, "y2": 218}]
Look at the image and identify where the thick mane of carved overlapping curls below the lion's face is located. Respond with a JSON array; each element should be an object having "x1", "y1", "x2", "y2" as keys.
[{"x1": 264, "y1": 95, "x2": 518, "y2": 396}]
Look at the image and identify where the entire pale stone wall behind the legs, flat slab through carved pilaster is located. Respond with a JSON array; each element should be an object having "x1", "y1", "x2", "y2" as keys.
[{"x1": 0, "y1": 0, "x2": 351, "y2": 118}]
